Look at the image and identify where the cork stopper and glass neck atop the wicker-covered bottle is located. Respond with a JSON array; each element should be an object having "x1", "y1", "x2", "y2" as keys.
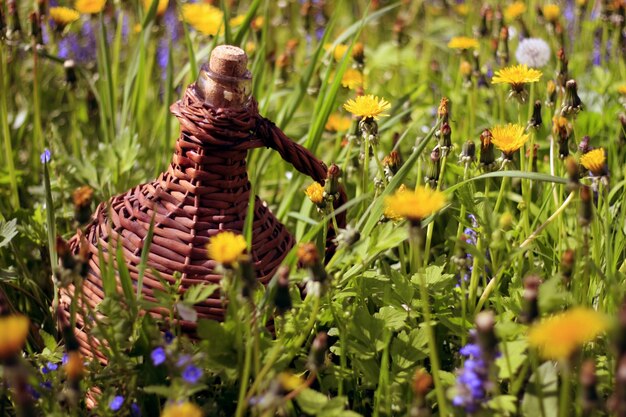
[{"x1": 195, "y1": 45, "x2": 252, "y2": 108}]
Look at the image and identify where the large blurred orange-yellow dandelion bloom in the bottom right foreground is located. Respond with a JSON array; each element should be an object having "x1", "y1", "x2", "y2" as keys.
[{"x1": 528, "y1": 307, "x2": 607, "y2": 360}]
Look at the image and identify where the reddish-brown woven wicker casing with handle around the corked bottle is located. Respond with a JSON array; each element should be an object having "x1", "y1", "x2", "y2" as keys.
[{"x1": 62, "y1": 47, "x2": 326, "y2": 359}]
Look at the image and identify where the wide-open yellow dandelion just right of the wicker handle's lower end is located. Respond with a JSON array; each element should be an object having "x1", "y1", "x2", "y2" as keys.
[{"x1": 385, "y1": 185, "x2": 446, "y2": 222}]
